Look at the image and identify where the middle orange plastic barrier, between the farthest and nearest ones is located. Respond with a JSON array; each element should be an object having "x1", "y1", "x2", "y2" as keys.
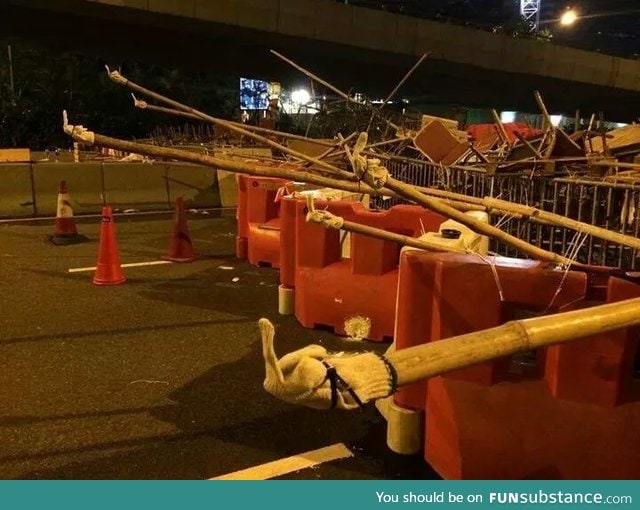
[{"x1": 280, "y1": 198, "x2": 445, "y2": 341}]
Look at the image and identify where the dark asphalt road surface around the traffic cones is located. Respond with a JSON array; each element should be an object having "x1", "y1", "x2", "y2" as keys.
[{"x1": 0, "y1": 211, "x2": 437, "y2": 479}]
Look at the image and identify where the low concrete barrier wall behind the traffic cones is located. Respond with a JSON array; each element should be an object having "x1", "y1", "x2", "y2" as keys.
[{"x1": 0, "y1": 161, "x2": 222, "y2": 218}]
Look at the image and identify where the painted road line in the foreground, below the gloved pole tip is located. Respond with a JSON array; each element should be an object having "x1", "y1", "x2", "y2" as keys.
[{"x1": 209, "y1": 443, "x2": 353, "y2": 480}]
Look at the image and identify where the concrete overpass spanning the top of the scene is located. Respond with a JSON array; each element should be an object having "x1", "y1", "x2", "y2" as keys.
[{"x1": 0, "y1": 0, "x2": 640, "y2": 121}]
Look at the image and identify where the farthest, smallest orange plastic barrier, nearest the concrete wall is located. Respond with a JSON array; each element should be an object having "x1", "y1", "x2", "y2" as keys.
[{"x1": 236, "y1": 175, "x2": 288, "y2": 268}]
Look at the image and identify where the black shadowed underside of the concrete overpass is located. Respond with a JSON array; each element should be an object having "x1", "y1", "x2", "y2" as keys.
[{"x1": 0, "y1": 0, "x2": 640, "y2": 122}]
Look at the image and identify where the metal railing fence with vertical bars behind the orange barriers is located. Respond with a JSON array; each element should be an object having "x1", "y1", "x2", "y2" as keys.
[{"x1": 372, "y1": 157, "x2": 640, "y2": 270}]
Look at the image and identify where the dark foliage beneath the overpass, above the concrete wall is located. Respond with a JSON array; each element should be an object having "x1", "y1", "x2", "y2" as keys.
[{"x1": 0, "y1": 40, "x2": 238, "y2": 150}]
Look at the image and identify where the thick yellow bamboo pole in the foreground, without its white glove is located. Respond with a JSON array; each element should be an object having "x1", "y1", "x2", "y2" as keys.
[{"x1": 387, "y1": 298, "x2": 640, "y2": 386}]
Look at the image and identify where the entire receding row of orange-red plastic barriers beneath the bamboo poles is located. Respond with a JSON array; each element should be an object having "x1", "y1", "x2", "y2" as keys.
[{"x1": 238, "y1": 177, "x2": 640, "y2": 479}]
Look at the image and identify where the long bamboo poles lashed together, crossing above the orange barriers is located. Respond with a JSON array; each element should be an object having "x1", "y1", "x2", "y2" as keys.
[{"x1": 65, "y1": 58, "x2": 640, "y2": 266}]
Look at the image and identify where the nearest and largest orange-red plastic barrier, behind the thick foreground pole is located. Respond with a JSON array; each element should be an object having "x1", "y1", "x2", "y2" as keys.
[{"x1": 396, "y1": 251, "x2": 640, "y2": 479}]
